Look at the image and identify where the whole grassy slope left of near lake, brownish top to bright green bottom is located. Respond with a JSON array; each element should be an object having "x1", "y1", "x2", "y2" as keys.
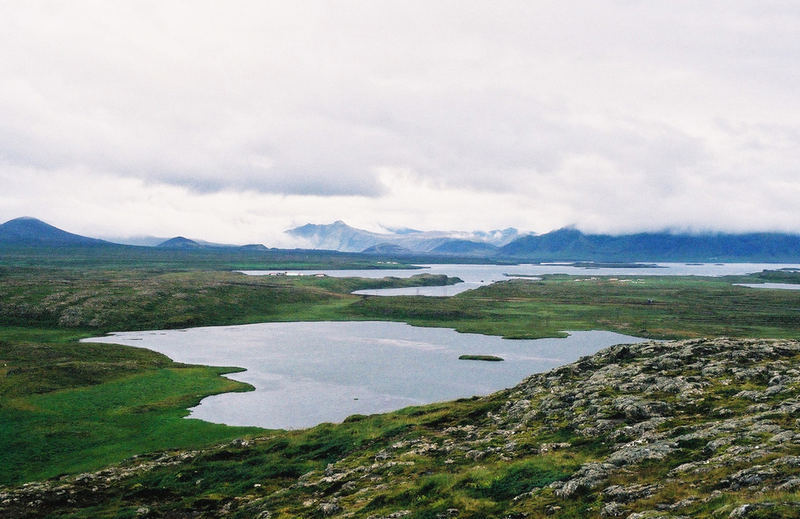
[{"x1": 0, "y1": 328, "x2": 260, "y2": 484}]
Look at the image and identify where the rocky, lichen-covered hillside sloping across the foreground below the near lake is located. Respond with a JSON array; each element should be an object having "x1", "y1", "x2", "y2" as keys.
[{"x1": 0, "y1": 338, "x2": 800, "y2": 519}]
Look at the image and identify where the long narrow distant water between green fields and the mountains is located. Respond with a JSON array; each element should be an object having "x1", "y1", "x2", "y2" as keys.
[{"x1": 239, "y1": 263, "x2": 800, "y2": 297}]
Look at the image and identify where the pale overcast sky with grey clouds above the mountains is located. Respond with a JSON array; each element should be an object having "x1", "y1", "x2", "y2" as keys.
[{"x1": 0, "y1": 0, "x2": 800, "y2": 246}]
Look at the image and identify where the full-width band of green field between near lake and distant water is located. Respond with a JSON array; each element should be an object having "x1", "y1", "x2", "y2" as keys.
[{"x1": 0, "y1": 267, "x2": 800, "y2": 338}]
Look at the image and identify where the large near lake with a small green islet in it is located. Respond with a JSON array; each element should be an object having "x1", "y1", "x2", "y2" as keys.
[{"x1": 84, "y1": 321, "x2": 644, "y2": 429}]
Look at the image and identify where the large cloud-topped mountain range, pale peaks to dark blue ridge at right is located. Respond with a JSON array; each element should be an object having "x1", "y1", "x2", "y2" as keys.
[{"x1": 286, "y1": 221, "x2": 800, "y2": 263}]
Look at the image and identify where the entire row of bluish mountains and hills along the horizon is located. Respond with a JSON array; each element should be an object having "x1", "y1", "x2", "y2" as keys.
[{"x1": 0, "y1": 217, "x2": 800, "y2": 263}]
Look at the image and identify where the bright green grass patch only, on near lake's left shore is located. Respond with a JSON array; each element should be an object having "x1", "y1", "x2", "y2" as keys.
[{"x1": 0, "y1": 356, "x2": 260, "y2": 484}]
